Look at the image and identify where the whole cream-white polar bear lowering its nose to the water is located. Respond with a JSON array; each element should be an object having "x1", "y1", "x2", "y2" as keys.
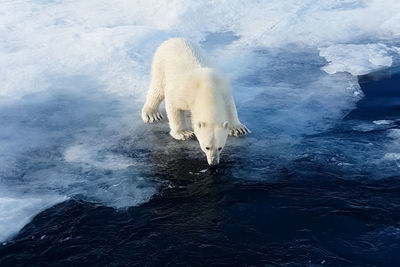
[{"x1": 142, "y1": 38, "x2": 250, "y2": 165}]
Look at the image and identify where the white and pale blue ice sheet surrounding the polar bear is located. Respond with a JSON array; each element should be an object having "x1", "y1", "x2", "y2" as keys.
[{"x1": 0, "y1": 0, "x2": 400, "y2": 243}]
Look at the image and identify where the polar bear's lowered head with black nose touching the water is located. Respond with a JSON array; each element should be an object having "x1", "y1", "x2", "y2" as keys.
[{"x1": 194, "y1": 121, "x2": 228, "y2": 166}]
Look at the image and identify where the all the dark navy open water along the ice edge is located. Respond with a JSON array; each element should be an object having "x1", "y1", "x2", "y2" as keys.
[{"x1": 0, "y1": 72, "x2": 400, "y2": 266}]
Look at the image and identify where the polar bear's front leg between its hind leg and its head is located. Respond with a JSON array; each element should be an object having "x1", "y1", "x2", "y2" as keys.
[{"x1": 165, "y1": 105, "x2": 194, "y2": 140}]
